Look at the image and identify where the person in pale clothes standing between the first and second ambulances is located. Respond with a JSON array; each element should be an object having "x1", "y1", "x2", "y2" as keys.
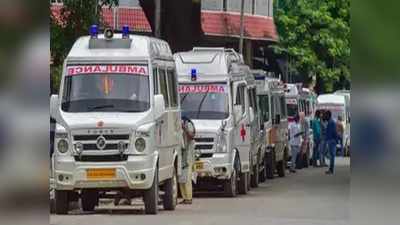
[{"x1": 179, "y1": 117, "x2": 196, "y2": 205}]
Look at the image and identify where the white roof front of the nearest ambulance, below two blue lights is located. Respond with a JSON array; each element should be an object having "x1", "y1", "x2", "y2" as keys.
[{"x1": 67, "y1": 34, "x2": 173, "y2": 60}]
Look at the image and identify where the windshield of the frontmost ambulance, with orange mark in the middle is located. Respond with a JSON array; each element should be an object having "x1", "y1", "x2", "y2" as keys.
[{"x1": 62, "y1": 64, "x2": 150, "y2": 112}]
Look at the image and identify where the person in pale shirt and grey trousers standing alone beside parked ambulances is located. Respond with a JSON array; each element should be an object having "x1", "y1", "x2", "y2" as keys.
[{"x1": 289, "y1": 115, "x2": 302, "y2": 173}]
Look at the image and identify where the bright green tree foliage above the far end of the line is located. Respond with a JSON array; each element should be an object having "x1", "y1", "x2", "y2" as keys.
[{"x1": 274, "y1": 0, "x2": 350, "y2": 91}]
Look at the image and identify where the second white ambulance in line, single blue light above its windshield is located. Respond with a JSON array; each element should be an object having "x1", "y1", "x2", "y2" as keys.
[{"x1": 174, "y1": 48, "x2": 262, "y2": 197}]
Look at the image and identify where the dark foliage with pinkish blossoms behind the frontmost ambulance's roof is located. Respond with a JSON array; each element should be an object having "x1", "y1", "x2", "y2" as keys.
[{"x1": 50, "y1": 0, "x2": 119, "y2": 93}]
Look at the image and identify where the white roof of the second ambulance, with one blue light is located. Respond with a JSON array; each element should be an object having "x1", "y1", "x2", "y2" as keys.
[{"x1": 174, "y1": 48, "x2": 250, "y2": 81}]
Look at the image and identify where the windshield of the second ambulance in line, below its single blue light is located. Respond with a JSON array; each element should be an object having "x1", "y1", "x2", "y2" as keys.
[{"x1": 179, "y1": 84, "x2": 229, "y2": 120}]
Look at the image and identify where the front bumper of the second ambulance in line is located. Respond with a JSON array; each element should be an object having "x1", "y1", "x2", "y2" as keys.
[{"x1": 194, "y1": 153, "x2": 233, "y2": 180}]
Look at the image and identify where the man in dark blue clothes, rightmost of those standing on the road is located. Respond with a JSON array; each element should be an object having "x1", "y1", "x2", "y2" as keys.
[{"x1": 326, "y1": 110, "x2": 338, "y2": 174}]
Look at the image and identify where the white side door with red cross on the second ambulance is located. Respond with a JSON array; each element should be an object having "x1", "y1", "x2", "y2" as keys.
[{"x1": 233, "y1": 82, "x2": 250, "y2": 172}]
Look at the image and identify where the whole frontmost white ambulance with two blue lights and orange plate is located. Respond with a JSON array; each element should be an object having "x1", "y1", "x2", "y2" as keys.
[{"x1": 50, "y1": 25, "x2": 183, "y2": 214}]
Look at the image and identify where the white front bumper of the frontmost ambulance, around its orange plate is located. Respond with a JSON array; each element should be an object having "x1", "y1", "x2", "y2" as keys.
[{"x1": 54, "y1": 154, "x2": 157, "y2": 190}]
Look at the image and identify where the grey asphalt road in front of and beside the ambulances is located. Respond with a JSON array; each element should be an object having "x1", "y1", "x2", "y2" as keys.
[{"x1": 50, "y1": 158, "x2": 350, "y2": 225}]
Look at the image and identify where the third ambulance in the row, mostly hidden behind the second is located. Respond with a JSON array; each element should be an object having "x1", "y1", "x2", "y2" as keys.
[{"x1": 253, "y1": 70, "x2": 289, "y2": 180}]
